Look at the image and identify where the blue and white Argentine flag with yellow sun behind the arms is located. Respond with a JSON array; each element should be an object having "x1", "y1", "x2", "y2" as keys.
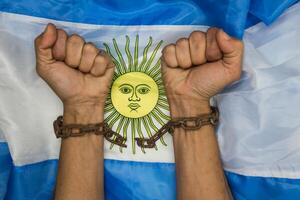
[{"x1": 0, "y1": 0, "x2": 300, "y2": 200}]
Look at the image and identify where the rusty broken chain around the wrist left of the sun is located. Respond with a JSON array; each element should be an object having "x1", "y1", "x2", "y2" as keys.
[{"x1": 53, "y1": 116, "x2": 127, "y2": 147}]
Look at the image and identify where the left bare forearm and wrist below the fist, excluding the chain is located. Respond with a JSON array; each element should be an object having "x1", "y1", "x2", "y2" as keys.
[{"x1": 55, "y1": 106, "x2": 104, "y2": 200}]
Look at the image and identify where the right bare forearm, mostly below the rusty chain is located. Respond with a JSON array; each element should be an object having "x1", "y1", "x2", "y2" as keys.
[{"x1": 173, "y1": 106, "x2": 231, "y2": 200}]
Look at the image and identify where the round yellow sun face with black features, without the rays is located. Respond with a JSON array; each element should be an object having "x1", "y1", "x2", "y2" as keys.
[{"x1": 111, "y1": 72, "x2": 158, "y2": 118}]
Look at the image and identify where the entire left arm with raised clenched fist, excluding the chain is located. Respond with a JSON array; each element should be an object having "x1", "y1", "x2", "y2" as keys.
[{"x1": 35, "y1": 24, "x2": 114, "y2": 200}]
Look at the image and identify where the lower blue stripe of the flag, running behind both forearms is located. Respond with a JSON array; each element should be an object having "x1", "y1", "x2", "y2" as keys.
[{"x1": 0, "y1": 154, "x2": 300, "y2": 200}]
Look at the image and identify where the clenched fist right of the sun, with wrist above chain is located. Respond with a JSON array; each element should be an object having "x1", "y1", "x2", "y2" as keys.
[{"x1": 161, "y1": 28, "x2": 243, "y2": 117}]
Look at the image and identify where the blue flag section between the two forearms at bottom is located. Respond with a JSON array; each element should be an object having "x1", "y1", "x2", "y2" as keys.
[{"x1": 105, "y1": 160, "x2": 176, "y2": 200}]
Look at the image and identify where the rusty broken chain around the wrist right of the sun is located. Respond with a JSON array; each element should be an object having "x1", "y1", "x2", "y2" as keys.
[{"x1": 135, "y1": 107, "x2": 219, "y2": 148}]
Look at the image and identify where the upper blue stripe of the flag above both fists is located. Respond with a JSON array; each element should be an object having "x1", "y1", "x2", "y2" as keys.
[{"x1": 0, "y1": 0, "x2": 250, "y2": 37}]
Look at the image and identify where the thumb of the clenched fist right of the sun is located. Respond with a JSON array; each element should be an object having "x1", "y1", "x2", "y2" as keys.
[{"x1": 216, "y1": 29, "x2": 243, "y2": 65}]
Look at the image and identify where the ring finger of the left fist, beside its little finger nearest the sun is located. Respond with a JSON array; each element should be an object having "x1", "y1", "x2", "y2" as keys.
[{"x1": 79, "y1": 43, "x2": 99, "y2": 73}]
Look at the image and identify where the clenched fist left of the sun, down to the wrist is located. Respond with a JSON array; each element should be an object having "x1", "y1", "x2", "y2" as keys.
[{"x1": 35, "y1": 24, "x2": 114, "y2": 111}]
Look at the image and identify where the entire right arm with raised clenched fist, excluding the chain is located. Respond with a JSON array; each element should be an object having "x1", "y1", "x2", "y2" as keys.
[{"x1": 161, "y1": 28, "x2": 243, "y2": 200}]
